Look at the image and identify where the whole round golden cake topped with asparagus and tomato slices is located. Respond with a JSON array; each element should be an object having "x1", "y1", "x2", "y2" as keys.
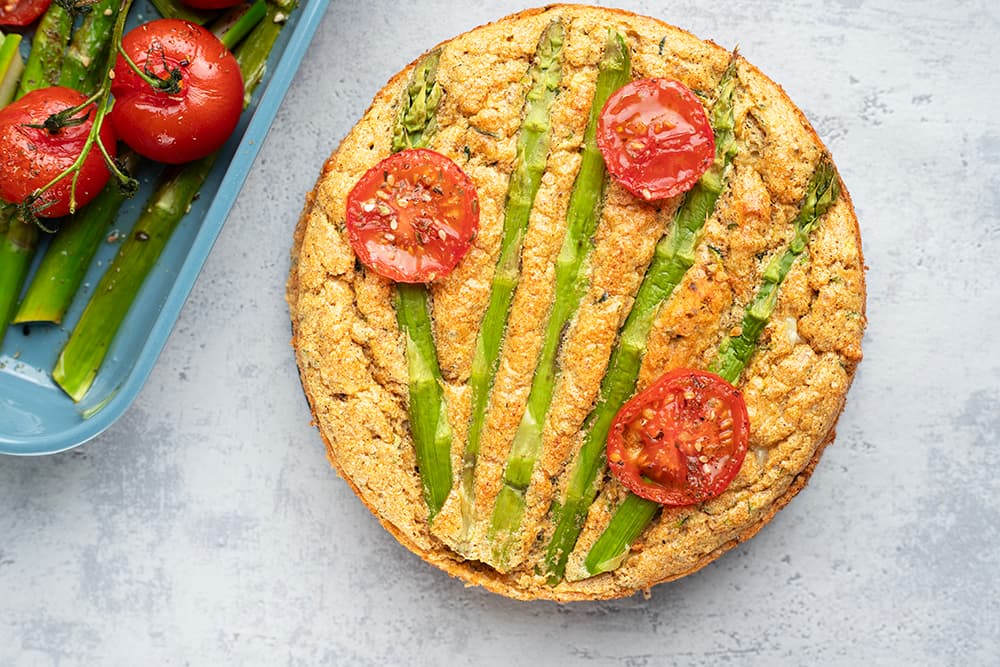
[{"x1": 287, "y1": 5, "x2": 865, "y2": 601}]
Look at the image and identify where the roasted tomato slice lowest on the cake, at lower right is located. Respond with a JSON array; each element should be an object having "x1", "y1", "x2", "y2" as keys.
[{"x1": 607, "y1": 368, "x2": 750, "y2": 505}]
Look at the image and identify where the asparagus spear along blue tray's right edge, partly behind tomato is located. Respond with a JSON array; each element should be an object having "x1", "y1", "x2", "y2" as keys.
[{"x1": 52, "y1": 5, "x2": 296, "y2": 401}]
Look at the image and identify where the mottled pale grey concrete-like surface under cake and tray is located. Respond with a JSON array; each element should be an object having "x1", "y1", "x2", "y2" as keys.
[{"x1": 0, "y1": 0, "x2": 1000, "y2": 665}]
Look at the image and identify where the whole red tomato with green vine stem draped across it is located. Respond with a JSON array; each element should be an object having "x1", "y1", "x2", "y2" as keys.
[{"x1": 0, "y1": 86, "x2": 115, "y2": 218}]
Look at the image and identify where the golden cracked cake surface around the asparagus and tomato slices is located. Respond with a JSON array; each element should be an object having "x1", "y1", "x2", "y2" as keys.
[{"x1": 287, "y1": 5, "x2": 865, "y2": 601}]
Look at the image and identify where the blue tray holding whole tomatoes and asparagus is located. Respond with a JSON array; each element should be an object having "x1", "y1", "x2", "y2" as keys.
[{"x1": 0, "y1": 0, "x2": 329, "y2": 455}]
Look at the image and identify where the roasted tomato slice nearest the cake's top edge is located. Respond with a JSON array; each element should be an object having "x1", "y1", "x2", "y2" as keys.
[{"x1": 597, "y1": 79, "x2": 715, "y2": 201}]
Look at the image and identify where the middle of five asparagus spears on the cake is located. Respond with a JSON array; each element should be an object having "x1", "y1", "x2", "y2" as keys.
[{"x1": 489, "y1": 30, "x2": 632, "y2": 571}]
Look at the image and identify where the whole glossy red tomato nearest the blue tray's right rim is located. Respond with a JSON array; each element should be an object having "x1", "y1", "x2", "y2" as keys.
[{"x1": 111, "y1": 19, "x2": 243, "y2": 164}]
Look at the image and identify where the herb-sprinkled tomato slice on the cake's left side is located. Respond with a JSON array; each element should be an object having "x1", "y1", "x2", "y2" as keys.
[{"x1": 347, "y1": 148, "x2": 479, "y2": 283}]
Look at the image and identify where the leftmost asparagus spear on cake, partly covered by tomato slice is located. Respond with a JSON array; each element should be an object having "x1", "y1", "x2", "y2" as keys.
[{"x1": 392, "y1": 51, "x2": 452, "y2": 521}]
